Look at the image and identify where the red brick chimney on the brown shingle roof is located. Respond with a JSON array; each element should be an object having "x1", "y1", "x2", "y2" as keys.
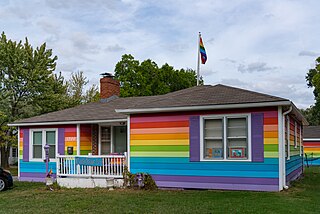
[{"x1": 100, "y1": 73, "x2": 120, "y2": 101}]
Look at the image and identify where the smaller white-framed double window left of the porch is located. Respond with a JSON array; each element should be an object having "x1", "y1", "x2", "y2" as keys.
[{"x1": 30, "y1": 129, "x2": 57, "y2": 160}]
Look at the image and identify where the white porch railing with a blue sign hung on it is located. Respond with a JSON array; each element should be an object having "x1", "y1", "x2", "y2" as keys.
[{"x1": 57, "y1": 154, "x2": 127, "y2": 178}]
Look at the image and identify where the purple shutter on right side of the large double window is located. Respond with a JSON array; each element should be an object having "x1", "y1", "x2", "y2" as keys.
[{"x1": 251, "y1": 113, "x2": 264, "y2": 162}]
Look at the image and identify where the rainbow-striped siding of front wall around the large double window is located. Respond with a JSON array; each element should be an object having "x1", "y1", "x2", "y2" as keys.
[{"x1": 130, "y1": 110, "x2": 279, "y2": 191}]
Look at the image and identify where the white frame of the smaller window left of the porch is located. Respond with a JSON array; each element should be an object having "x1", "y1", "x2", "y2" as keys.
[{"x1": 29, "y1": 128, "x2": 58, "y2": 162}]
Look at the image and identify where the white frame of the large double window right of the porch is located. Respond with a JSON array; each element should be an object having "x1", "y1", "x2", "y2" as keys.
[{"x1": 200, "y1": 114, "x2": 252, "y2": 162}]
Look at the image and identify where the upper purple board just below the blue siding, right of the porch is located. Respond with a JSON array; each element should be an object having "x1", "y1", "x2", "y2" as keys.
[{"x1": 152, "y1": 175, "x2": 279, "y2": 185}]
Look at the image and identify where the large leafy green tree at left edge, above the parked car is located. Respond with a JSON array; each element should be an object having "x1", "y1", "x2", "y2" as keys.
[{"x1": 0, "y1": 32, "x2": 67, "y2": 167}]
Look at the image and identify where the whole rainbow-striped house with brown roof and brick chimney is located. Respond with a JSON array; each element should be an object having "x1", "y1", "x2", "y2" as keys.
[{"x1": 11, "y1": 76, "x2": 307, "y2": 191}]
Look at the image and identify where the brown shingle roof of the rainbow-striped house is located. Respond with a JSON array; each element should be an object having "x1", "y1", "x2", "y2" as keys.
[{"x1": 12, "y1": 84, "x2": 289, "y2": 125}]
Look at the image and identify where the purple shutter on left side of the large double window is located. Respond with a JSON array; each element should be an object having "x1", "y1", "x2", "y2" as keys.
[{"x1": 189, "y1": 116, "x2": 200, "y2": 162}]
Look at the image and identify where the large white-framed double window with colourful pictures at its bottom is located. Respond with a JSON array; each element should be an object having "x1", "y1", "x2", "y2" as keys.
[{"x1": 201, "y1": 115, "x2": 251, "y2": 160}]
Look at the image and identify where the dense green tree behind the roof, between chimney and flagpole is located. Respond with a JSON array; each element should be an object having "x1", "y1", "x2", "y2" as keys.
[{"x1": 115, "y1": 54, "x2": 203, "y2": 97}]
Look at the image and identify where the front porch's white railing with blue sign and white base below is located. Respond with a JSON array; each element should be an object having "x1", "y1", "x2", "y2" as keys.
[{"x1": 56, "y1": 153, "x2": 127, "y2": 188}]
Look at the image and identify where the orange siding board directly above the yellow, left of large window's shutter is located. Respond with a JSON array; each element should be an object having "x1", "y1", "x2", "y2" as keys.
[{"x1": 130, "y1": 133, "x2": 189, "y2": 140}]
